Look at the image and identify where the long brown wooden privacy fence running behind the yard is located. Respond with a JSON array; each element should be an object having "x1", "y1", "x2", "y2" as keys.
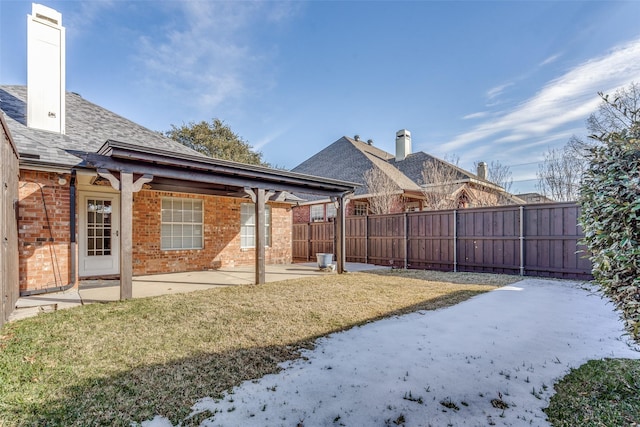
[{"x1": 293, "y1": 203, "x2": 592, "y2": 279}]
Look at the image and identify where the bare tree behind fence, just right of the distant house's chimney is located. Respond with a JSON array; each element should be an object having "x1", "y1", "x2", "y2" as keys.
[{"x1": 421, "y1": 156, "x2": 462, "y2": 209}]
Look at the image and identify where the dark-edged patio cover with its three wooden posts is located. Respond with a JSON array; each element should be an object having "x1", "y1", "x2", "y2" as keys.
[{"x1": 69, "y1": 140, "x2": 359, "y2": 299}]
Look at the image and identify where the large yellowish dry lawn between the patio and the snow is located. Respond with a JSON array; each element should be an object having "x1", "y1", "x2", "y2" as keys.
[{"x1": 0, "y1": 271, "x2": 518, "y2": 426}]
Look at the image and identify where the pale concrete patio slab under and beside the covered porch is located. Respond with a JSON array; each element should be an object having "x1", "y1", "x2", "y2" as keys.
[{"x1": 9, "y1": 262, "x2": 388, "y2": 321}]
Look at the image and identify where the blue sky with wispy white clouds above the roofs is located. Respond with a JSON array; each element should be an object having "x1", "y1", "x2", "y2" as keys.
[{"x1": 0, "y1": 0, "x2": 640, "y2": 192}]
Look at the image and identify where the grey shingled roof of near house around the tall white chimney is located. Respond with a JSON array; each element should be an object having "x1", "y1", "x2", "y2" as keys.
[{"x1": 0, "y1": 86, "x2": 201, "y2": 168}]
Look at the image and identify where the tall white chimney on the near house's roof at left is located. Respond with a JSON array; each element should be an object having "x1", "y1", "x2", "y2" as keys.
[{"x1": 27, "y1": 3, "x2": 65, "y2": 134}]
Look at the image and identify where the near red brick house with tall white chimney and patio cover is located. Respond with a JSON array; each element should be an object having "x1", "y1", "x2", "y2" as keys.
[{"x1": 0, "y1": 4, "x2": 354, "y2": 308}]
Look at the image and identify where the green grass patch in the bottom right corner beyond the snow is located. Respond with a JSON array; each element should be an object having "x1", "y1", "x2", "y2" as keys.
[{"x1": 545, "y1": 359, "x2": 640, "y2": 427}]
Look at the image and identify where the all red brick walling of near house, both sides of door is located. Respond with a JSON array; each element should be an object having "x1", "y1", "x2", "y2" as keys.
[{"x1": 18, "y1": 177, "x2": 292, "y2": 291}]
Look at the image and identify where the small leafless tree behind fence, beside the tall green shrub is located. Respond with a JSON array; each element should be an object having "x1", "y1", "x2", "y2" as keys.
[{"x1": 536, "y1": 146, "x2": 586, "y2": 202}]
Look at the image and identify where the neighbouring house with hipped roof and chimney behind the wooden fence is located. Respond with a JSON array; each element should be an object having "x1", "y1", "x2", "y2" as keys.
[{"x1": 292, "y1": 129, "x2": 524, "y2": 223}]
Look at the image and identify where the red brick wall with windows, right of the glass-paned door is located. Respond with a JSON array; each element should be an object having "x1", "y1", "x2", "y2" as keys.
[{"x1": 133, "y1": 190, "x2": 292, "y2": 275}]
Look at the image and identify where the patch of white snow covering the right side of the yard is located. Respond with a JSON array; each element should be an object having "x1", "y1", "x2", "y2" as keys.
[{"x1": 141, "y1": 279, "x2": 640, "y2": 427}]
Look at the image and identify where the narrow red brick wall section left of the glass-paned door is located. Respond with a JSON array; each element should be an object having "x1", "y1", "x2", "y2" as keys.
[{"x1": 18, "y1": 170, "x2": 71, "y2": 291}]
